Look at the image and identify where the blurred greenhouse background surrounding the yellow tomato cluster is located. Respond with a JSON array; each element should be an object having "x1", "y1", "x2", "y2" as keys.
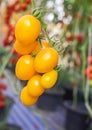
[{"x1": 0, "y1": 0, "x2": 92, "y2": 130}]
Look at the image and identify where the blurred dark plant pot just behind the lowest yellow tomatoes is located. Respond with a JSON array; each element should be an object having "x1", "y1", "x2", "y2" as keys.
[{"x1": 36, "y1": 90, "x2": 65, "y2": 111}]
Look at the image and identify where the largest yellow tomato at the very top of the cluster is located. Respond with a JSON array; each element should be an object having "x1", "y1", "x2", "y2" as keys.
[{"x1": 15, "y1": 15, "x2": 41, "y2": 45}]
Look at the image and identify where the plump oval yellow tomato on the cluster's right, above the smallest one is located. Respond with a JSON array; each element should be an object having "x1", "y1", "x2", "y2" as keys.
[{"x1": 34, "y1": 47, "x2": 59, "y2": 73}]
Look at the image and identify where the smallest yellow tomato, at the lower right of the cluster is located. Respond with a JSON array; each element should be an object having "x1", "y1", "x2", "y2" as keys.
[{"x1": 41, "y1": 70, "x2": 58, "y2": 89}]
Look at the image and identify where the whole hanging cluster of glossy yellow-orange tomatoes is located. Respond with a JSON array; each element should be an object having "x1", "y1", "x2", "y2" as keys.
[{"x1": 14, "y1": 15, "x2": 59, "y2": 106}]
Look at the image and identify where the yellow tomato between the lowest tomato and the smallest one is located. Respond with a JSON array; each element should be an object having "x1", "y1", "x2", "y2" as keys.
[{"x1": 27, "y1": 75, "x2": 44, "y2": 97}]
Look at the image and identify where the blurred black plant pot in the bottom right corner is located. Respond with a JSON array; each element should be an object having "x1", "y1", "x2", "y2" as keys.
[{"x1": 64, "y1": 101, "x2": 91, "y2": 130}]
